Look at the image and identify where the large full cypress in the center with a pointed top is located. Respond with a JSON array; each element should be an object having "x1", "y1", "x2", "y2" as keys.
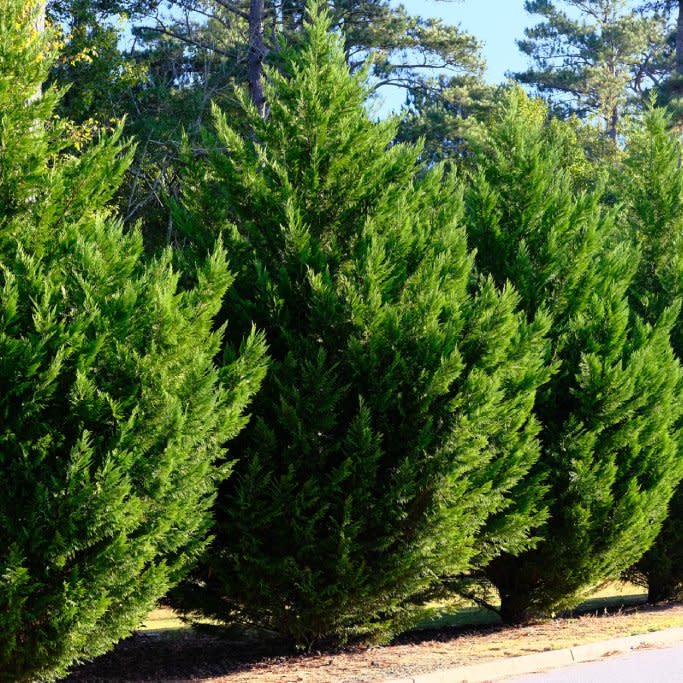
[{"x1": 175, "y1": 4, "x2": 546, "y2": 646}]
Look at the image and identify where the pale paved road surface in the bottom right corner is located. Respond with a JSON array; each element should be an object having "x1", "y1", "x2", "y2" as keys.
[{"x1": 506, "y1": 645, "x2": 683, "y2": 683}]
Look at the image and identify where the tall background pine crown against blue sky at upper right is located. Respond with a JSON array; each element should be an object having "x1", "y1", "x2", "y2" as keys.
[{"x1": 515, "y1": 0, "x2": 671, "y2": 140}]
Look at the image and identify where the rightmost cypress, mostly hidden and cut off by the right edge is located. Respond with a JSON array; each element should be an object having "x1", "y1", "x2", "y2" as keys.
[{"x1": 620, "y1": 109, "x2": 683, "y2": 602}]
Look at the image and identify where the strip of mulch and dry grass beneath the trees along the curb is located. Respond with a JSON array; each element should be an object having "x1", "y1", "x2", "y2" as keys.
[{"x1": 67, "y1": 604, "x2": 683, "y2": 683}]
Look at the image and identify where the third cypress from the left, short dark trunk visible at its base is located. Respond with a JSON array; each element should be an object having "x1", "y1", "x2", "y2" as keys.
[{"x1": 467, "y1": 91, "x2": 682, "y2": 621}]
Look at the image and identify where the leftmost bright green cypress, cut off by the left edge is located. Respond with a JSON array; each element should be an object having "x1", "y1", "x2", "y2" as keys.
[{"x1": 0, "y1": 0, "x2": 264, "y2": 681}]
